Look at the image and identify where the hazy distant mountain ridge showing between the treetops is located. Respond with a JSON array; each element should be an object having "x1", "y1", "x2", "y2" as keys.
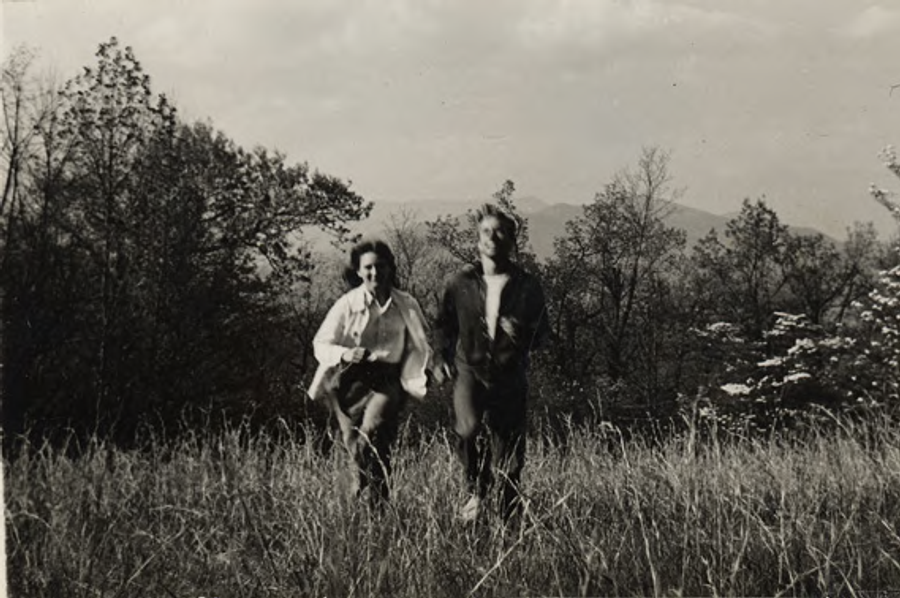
[{"x1": 307, "y1": 196, "x2": 836, "y2": 259}]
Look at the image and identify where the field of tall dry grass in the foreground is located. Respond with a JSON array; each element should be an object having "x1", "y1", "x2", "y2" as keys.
[{"x1": 5, "y1": 424, "x2": 900, "y2": 598}]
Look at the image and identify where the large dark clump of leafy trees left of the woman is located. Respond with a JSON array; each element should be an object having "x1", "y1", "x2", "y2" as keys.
[{"x1": 2, "y1": 38, "x2": 370, "y2": 440}]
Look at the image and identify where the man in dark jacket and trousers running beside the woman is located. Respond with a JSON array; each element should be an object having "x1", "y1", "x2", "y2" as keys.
[{"x1": 435, "y1": 205, "x2": 549, "y2": 521}]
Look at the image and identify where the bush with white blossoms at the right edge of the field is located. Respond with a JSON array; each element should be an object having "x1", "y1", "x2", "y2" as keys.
[{"x1": 700, "y1": 146, "x2": 900, "y2": 426}]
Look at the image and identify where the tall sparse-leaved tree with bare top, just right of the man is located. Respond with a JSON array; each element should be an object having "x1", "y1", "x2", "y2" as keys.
[{"x1": 546, "y1": 148, "x2": 685, "y2": 410}]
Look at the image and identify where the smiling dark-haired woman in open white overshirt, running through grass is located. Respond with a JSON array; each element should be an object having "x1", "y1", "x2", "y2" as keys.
[{"x1": 309, "y1": 241, "x2": 431, "y2": 505}]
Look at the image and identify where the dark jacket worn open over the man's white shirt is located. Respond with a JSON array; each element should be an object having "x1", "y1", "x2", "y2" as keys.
[{"x1": 435, "y1": 264, "x2": 550, "y2": 374}]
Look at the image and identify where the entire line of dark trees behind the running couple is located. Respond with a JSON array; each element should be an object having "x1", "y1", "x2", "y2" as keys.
[{"x1": 0, "y1": 38, "x2": 900, "y2": 444}]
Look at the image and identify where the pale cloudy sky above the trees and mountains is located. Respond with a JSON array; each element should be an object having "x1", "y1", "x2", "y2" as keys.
[{"x1": 0, "y1": 0, "x2": 900, "y2": 238}]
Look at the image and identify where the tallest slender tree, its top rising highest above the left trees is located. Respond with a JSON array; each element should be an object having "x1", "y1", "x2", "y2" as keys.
[{"x1": 53, "y1": 38, "x2": 176, "y2": 426}]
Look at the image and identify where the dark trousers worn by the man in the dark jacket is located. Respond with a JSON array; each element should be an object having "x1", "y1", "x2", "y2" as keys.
[{"x1": 453, "y1": 362, "x2": 528, "y2": 519}]
